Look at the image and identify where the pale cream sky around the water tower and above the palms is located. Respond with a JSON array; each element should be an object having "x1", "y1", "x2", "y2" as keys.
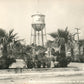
[{"x1": 0, "y1": 0, "x2": 84, "y2": 44}]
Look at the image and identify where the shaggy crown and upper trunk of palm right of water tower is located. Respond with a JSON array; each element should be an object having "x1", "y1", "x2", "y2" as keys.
[{"x1": 50, "y1": 28, "x2": 69, "y2": 53}]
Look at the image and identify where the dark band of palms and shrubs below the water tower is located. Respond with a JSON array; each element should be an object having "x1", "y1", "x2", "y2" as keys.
[{"x1": 0, "y1": 28, "x2": 84, "y2": 69}]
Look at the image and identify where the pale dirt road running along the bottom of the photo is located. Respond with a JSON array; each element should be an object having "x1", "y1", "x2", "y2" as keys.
[{"x1": 0, "y1": 71, "x2": 84, "y2": 84}]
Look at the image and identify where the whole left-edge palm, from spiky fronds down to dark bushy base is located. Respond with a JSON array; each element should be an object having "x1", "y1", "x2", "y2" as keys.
[{"x1": 0, "y1": 29, "x2": 17, "y2": 68}]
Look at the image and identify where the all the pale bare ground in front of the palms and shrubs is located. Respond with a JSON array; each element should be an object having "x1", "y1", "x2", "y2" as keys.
[{"x1": 0, "y1": 63, "x2": 84, "y2": 84}]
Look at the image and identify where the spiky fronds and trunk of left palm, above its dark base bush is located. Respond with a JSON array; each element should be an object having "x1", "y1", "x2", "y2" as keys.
[{"x1": 2, "y1": 29, "x2": 17, "y2": 58}]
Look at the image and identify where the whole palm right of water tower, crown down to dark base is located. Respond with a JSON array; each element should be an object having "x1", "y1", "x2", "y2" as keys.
[{"x1": 50, "y1": 28, "x2": 72, "y2": 67}]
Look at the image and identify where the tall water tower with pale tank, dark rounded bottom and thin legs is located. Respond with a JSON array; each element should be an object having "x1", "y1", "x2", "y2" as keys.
[{"x1": 31, "y1": 13, "x2": 46, "y2": 46}]
